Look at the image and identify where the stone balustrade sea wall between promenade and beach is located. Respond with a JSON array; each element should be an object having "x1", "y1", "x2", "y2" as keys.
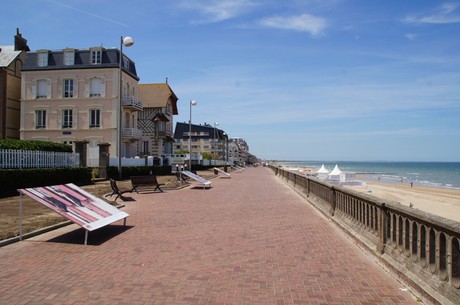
[{"x1": 269, "y1": 165, "x2": 460, "y2": 304}]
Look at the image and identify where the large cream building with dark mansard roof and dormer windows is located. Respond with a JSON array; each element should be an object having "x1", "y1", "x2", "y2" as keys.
[{"x1": 20, "y1": 46, "x2": 143, "y2": 166}]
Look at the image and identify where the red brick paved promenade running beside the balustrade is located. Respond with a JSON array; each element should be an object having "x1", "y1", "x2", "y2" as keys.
[{"x1": 0, "y1": 168, "x2": 419, "y2": 305}]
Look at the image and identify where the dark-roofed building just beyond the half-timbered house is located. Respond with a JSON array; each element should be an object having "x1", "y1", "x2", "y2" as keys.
[{"x1": 174, "y1": 123, "x2": 228, "y2": 161}]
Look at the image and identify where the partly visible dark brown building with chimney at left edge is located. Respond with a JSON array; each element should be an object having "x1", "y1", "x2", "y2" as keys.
[{"x1": 0, "y1": 29, "x2": 29, "y2": 139}]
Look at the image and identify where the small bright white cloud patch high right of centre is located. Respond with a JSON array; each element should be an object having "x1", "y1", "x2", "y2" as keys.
[{"x1": 259, "y1": 14, "x2": 327, "y2": 36}]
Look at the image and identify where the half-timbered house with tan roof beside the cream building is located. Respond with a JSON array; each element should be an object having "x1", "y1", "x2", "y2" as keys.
[{"x1": 137, "y1": 83, "x2": 178, "y2": 158}]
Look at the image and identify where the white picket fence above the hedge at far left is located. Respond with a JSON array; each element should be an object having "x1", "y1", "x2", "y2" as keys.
[{"x1": 0, "y1": 149, "x2": 80, "y2": 168}]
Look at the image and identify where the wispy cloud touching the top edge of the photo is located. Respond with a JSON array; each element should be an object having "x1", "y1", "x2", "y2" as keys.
[{"x1": 181, "y1": 0, "x2": 257, "y2": 23}]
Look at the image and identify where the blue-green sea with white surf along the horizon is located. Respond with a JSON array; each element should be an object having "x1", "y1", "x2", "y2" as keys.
[{"x1": 275, "y1": 161, "x2": 460, "y2": 189}]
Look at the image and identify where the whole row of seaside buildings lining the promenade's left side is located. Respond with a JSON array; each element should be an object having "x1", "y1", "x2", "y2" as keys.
[{"x1": 0, "y1": 29, "x2": 251, "y2": 166}]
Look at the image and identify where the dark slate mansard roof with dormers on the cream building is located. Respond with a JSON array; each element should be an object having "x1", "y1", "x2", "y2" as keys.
[{"x1": 22, "y1": 47, "x2": 139, "y2": 80}]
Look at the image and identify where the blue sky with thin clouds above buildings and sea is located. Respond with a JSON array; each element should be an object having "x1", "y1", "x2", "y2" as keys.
[{"x1": 0, "y1": 0, "x2": 460, "y2": 161}]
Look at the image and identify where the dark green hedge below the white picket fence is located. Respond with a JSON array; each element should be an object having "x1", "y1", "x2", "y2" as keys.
[{"x1": 0, "y1": 167, "x2": 92, "y2": 197}]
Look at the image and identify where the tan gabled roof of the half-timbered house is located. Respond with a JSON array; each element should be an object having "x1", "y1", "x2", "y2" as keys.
[{"x1": 139, "y1": 83, "x2": 178, "y2": 114}]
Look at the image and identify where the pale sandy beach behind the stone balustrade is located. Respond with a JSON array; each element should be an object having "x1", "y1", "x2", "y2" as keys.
[{"x1": 342, "y1": 182, "x2": 460, "y2": 222}]
